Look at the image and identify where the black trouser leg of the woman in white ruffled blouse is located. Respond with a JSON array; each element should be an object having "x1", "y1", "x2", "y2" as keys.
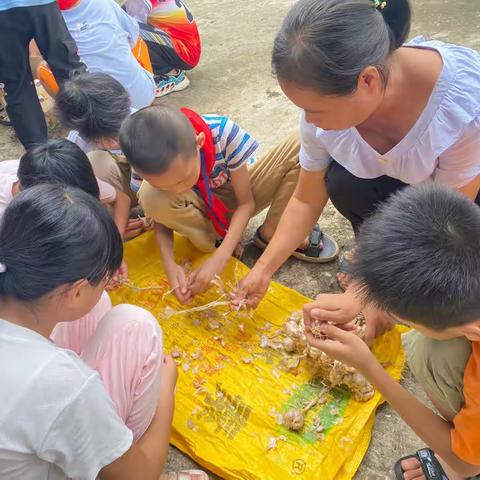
[{"x1": 325, "y1": 160, "x2": 407, "y2": 233}]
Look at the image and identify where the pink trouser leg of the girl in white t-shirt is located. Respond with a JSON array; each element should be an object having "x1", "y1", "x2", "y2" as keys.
[{"x1": 81, "y1": 305, "x2": 163, "y2": 441}]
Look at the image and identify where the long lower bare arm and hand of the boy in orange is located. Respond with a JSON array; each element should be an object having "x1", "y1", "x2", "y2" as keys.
[{"x1": 307, "y1": 324, "x2": 480, "y2": 477}]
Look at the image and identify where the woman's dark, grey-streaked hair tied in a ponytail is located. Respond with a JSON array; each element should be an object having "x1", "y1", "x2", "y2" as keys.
[{"x1": 272, "y1": 0, "x2": 411, "y2": 95}]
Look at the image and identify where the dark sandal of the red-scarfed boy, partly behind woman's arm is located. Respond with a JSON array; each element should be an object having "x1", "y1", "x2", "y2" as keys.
[{"x1": 253, "y1": 224, "x2": 339, "y2": 263}]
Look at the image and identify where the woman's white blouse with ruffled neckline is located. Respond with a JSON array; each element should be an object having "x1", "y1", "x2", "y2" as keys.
[{"x1": 300, "y1": 37, "x2": 480, "y2": 188}]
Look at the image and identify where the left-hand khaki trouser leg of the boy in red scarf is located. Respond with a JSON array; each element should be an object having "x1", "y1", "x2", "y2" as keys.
[{"x1": 138, "y1": 182, "x2": 218, "y2": 252}]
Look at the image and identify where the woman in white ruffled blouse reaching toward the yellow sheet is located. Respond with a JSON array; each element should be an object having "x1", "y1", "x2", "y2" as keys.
[{"x1": 237, "y1": 0, "x2": 480, "y2": 307}]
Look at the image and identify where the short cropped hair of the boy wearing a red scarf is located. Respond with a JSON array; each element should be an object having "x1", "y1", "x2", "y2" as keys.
[{"x1": 120, "y1": 105, "x2": 197, "y2": 174}]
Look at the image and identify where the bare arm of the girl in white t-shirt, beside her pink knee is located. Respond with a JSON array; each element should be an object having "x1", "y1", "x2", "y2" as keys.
[{"x1": 100, "y1": 356, "x2": 178, "y2": 480}]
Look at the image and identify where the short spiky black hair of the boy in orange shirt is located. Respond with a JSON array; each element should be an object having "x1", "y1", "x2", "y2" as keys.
[{"x1": 352, "y1": 183, "x2": 480, "y2": 330}]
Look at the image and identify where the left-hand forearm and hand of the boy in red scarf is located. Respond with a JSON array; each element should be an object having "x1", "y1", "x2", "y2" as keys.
[{"x1": 154, "y1": 222, "x2": 192, "y2": 303}]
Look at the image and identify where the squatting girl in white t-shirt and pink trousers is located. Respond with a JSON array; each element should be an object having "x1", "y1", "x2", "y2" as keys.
[{"x1": 0, "y1": 185, "x2": 205, "y2": 480}]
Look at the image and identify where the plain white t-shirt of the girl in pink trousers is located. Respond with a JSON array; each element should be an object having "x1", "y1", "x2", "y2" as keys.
[{"x1": 0, "y1": 320, "x2": 133, "y2": 480}]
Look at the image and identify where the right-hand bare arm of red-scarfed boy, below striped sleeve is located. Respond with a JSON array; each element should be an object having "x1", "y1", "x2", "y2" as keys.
[{"x1": 189, "y1": 164, "x2": 255, "y2": 295}]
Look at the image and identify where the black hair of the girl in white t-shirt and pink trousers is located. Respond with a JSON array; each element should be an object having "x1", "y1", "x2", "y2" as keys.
[{"x1": 0, "y1": 184, "x2": 123, "y2": 302}]
